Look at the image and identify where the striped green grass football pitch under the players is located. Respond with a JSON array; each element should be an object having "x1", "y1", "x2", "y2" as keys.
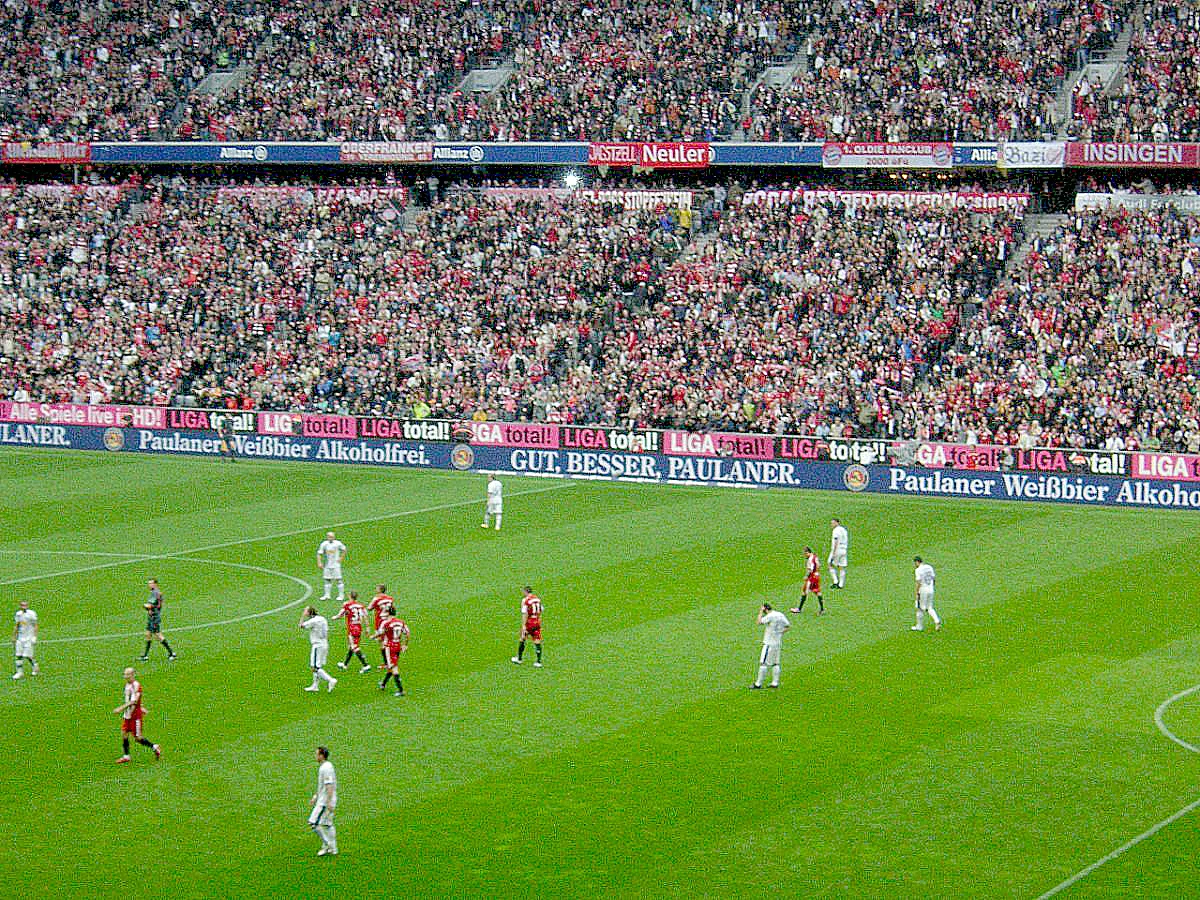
[{"x1": 0, "y1": 452, "x2": 1200, "y2": 899}]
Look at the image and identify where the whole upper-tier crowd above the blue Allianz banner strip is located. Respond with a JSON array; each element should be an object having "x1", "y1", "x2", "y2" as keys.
[{"x1": 0, "y1": 0, "x2": 1142, "y2": 140}]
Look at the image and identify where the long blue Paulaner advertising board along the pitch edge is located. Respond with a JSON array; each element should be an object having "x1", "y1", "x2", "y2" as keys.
[{"x1": 11, "y1": 422, "x2": 1200, "y2": 510}]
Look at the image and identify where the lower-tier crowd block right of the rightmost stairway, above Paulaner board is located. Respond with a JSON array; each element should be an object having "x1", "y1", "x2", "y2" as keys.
[{"x1": 955, "y1": 208, "x2": 1200, "y2": 452}]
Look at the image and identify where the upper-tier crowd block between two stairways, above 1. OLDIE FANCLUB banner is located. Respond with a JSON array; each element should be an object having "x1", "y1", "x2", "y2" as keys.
[{"x1": 750, "y1": 0, "x2": 1130, "y2": 142}]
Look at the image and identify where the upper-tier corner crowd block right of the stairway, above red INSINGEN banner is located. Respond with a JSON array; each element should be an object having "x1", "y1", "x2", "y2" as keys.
[{"x1": 1074, "y1": 0, "x2": 1200, "y2": 142}]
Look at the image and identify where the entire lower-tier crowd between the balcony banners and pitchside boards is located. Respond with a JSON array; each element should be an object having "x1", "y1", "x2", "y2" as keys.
[{"x1": 0, "y1": 176, "x2": 1200, "y2": 449}]
